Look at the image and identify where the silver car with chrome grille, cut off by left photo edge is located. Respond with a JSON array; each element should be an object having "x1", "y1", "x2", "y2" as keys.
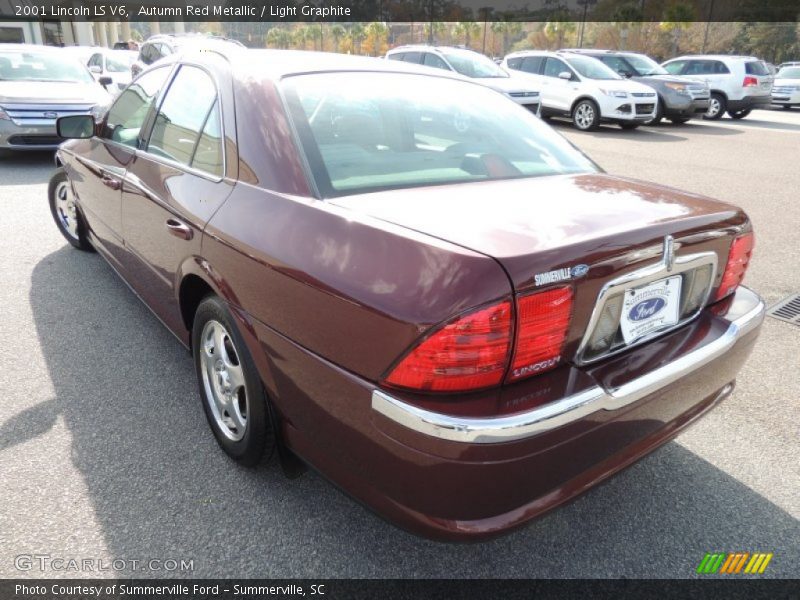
[{"x1": 0, "y1": 44, "x2": 110, "y2": 150}]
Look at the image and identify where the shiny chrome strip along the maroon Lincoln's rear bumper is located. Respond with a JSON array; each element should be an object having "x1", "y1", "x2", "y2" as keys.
[{"x1": 372, "y1": 287, "x2": 766, "y2": 444}]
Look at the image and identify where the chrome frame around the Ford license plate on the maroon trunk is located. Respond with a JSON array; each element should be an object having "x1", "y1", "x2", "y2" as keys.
[{"x1": 575, "y1": 245, "x2": 718, "y2": 366}]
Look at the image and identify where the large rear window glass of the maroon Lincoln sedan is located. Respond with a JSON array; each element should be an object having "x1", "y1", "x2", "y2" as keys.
[{"x1": 283, "y1": 73, "x2": 597, "y2": 200}]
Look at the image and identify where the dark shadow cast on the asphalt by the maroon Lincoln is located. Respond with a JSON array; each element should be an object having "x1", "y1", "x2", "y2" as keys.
[{"x1": 26, "y1": 246, "x2": 800, "y2": 578}]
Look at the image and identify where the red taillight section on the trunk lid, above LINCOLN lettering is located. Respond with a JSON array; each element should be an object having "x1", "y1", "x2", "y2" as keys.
[{"x1": 507, "y1": 287, "x2": 572, "y2": 381}]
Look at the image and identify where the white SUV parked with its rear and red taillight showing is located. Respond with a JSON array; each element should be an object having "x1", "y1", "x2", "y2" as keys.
[{"x1": 661, "y1": 54, "x2": 773, "y2": 119}]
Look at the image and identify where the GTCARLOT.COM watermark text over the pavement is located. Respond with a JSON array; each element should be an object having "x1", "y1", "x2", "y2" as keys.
[{"x1": 14, "y1": 554, "x2": 194, "y2": 573}]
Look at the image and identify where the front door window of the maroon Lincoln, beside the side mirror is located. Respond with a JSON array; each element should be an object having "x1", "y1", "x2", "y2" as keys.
[{"x1": 102, "y1": 67, "x2": 170, "y2": 148}]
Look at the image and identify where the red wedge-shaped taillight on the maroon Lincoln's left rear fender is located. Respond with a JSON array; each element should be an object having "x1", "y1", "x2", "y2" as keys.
[{"x1": 385, "y1": 300, "x2": 511, "y2": 392}]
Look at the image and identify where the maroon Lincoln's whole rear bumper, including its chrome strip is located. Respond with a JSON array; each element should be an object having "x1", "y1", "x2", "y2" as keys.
[{"x1": 259, "y1": 288, "x2": 764, "y2": 541}]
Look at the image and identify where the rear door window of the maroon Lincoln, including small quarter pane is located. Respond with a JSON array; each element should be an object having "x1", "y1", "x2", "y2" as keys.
[{"x1": 147, "y1": 65, "x2": 222, "y2": 175}]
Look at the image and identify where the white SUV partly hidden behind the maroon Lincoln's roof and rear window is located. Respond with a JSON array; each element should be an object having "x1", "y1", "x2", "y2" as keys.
[{"x1": 386, "y1": 45, "x2": 539, "y2": 113}]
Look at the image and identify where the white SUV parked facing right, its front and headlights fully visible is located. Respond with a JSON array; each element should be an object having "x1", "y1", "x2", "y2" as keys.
[{"x1": 502, "y1": 50, "x2": 658, "y2": 131}]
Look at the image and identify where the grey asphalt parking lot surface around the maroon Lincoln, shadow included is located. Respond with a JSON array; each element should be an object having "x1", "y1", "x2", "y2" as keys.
[{"x1": 0, "y1": 111, "x2": 800, "y2": 578}]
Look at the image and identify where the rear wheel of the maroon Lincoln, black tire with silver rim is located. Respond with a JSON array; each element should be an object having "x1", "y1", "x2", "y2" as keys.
[{"x1": 192, "y1": 295, "x2": 275, "y2": 467}]
